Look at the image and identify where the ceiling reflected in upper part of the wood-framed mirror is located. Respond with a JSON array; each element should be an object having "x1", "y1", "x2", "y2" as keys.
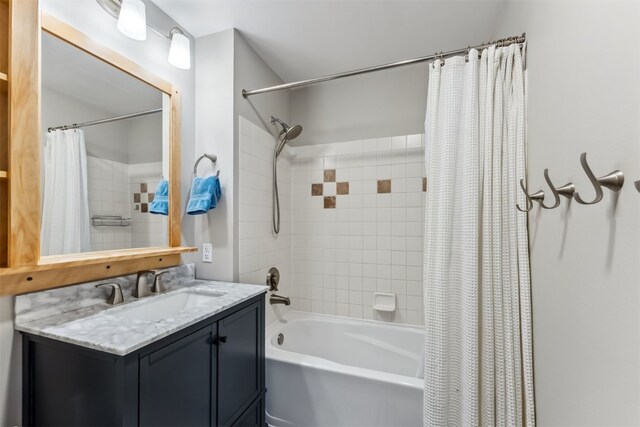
[{"x1": 42, "y1": 32, "x2": 162, "y2": 119}]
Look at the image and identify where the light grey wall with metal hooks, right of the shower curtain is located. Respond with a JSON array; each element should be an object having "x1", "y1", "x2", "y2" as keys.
[{"x1": 495, "y1": 1, "x2": 640, "y2": 426}]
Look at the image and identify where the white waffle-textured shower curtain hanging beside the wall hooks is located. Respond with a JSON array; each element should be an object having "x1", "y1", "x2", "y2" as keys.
[{"x1": 424, "y1": 44, "x2": 535, "y2": 427}]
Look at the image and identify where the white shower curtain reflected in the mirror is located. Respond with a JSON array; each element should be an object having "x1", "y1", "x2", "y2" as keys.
[{"x1": 40, "y1": 129, "x2": 91, "y2": 255}]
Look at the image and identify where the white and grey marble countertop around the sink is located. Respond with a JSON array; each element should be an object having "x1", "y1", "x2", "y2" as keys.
[{"x1": 15, "y1": 280, "x2": 267, "y2": 356}]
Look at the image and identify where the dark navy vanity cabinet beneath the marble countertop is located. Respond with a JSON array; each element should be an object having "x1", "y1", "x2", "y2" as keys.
[{"x1": 23, "y1": 295, "x2": 265, "y2": 427}]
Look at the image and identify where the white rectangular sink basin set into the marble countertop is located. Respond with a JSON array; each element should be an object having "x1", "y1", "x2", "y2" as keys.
[{"x1": 109, "y1": 291, "x2": 226, "y2": 322}]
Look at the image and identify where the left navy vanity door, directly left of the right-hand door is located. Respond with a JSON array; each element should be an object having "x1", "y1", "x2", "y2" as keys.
[{"x1": 140, "y1": 325, "x2": 216, "y2": 427}]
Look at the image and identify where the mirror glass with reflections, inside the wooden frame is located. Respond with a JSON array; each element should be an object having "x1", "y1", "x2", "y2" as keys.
[{"x1": 40, "y1": 32, "x2": 168, "y2": 256}]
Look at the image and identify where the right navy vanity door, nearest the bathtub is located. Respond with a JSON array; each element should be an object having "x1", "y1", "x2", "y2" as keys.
[{"x1": 218, "y1": 303, "x2": 264, "y2": 426}]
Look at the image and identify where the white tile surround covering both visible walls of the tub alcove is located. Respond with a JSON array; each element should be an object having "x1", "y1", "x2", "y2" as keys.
[{"x1": 239, "y1": 117, "x2": 425, "y2": 324}]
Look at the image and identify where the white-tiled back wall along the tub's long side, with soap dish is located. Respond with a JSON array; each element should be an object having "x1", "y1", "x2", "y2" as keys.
[{"x1": 291, "y1": 135, "x2": 425, "y2": 324}]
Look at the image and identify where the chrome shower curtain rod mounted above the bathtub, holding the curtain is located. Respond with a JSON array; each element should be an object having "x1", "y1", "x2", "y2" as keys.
[{"x1": 242, "y1": 33, "x2": 526, "y2": 98}]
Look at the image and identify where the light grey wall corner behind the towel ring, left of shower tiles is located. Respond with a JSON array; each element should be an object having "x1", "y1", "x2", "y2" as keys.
[{"x1": 195, "y1": 29, "x2": 289, "y2": 280}]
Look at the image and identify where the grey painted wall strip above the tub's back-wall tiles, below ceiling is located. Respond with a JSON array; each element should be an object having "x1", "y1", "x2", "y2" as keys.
[{"x1": 290, "y1": 59, "x2": 428, "y2": 145}]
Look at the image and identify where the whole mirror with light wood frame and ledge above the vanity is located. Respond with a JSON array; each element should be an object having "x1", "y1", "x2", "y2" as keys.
[{"x1": 0, "y1": 11, "x2": 196, "y2": 295}]
